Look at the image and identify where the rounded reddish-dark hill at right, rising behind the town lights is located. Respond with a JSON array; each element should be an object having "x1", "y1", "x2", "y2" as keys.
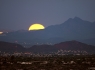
[{"x1": 54, "y1": 40, "x2": 95, "y2": 53}]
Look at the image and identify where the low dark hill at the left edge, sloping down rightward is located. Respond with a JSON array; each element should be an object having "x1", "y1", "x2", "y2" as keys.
[{"x1": 0, "y1": 41, "x2": 25, "y2": 52}]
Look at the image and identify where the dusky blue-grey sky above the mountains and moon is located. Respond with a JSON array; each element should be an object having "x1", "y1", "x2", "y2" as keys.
[{"x1": 0, "y1": 0, "x2": 95, "y2": 30}]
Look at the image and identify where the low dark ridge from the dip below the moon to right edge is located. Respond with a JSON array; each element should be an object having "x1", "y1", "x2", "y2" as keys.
[{"x1": 28, "y1": 40, "x2": 95, "y2": 53}]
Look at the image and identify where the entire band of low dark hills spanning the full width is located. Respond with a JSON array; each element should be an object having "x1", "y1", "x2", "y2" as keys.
[{"x1": 0, "y1": 40, "x2": 95, "y2": 54}]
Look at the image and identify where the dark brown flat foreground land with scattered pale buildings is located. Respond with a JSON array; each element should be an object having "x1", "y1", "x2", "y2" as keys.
[{"x1": 0, "y1": 55, "x2": 95, "y2": 70}]
